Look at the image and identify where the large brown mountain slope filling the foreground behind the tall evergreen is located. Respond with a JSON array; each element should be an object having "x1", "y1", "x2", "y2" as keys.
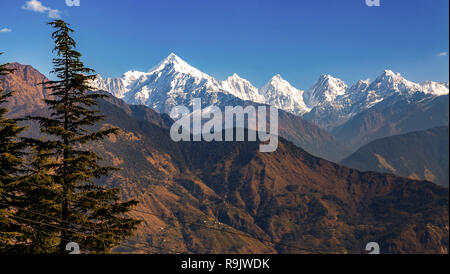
[{"x1": 1, "y1": 63, "x2": 449, "y2": 253}]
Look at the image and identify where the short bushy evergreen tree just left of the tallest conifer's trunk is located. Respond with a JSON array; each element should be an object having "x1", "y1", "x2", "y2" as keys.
[{"x1": 9, "y1": 144, "x2": 62, "y2": 254}]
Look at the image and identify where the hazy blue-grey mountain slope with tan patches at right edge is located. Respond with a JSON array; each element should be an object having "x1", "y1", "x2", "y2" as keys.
[{"x1": 342, "y1": 126, "x2": 449, "y2": 187}]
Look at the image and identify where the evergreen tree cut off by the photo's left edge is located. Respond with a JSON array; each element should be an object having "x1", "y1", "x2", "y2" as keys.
[{"x1": 0, "y1": 53, "x2": 24, "y2": 252}]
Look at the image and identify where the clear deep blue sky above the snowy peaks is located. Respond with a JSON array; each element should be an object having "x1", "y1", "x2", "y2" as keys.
[{"x1": 0, "y1": 0, "x2": 449, "y2": 89}]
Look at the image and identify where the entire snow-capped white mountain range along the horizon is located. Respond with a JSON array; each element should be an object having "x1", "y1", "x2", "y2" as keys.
[{"x1": 93, "y1": 53, "x2": 449, "y2": 130}]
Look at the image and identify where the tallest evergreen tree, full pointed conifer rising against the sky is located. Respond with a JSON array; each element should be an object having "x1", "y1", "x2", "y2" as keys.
[{"x1": 24, "y1": 20, "x2": 140, "y2": 253}]
